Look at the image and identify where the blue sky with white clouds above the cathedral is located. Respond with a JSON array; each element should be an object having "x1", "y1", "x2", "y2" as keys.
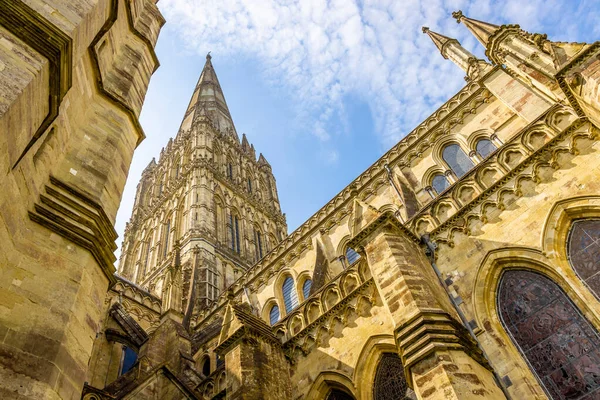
[{"x1": 116, "y1": 0, "x2": 600, "y2": 258}]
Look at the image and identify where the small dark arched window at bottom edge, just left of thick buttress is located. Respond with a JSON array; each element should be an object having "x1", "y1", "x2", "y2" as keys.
[{"x1": 373, "y1": 353, "x2": 408, "y2": 400}]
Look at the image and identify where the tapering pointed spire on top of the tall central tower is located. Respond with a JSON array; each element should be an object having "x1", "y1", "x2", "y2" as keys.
[{"x1": 181, "y1": 53, "x2": 237, "y2": 137}]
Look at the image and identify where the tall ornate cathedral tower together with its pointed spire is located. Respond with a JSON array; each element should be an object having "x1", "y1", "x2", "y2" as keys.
[{"x1": 119, "y1": 55, "x2": 287, "y2": 321}]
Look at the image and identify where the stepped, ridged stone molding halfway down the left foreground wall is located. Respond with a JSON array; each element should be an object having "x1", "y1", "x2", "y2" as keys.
[{"x1": 29, "y1": 176, "x2": 117, "y2": 285}]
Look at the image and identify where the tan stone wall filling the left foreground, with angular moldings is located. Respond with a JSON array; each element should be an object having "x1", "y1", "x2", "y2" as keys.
[{"x1": 0, "y1": 0, "x2": 165, "y2": 399}]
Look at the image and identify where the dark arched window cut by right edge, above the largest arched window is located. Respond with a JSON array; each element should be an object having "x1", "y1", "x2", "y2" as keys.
[{"x1": 568, "y1": 219, "x2": 600, "y2": 299}]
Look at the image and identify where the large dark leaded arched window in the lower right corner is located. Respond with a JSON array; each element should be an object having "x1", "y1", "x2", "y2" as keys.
[{"x1": 498, "y1": 270, "x2": 600, "y2": 400}]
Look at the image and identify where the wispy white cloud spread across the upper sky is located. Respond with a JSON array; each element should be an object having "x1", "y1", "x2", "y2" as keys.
[{"x1": 158, "y1": 0, "x2": 600, "y2": 148}]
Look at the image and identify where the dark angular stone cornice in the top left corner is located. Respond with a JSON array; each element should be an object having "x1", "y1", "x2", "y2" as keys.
[{"x1": 0, "y1": 1, "x2": 73, "y2": 168}]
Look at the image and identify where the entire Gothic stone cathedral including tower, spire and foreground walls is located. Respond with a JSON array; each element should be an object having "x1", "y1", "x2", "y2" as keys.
[{"x1": 0, "y1": 0, "x2": 600, "y2": 400}]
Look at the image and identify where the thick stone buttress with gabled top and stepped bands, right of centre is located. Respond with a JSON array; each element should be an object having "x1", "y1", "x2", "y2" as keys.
[{"x1": 353, "y1": 213, "x2": 505, "y2": 400}]
